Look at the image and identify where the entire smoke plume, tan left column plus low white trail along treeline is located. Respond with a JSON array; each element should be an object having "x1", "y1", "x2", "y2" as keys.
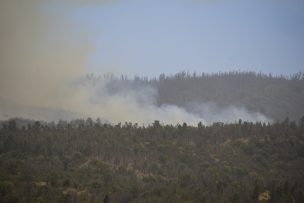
[{"x1": 0, "y1": 0, "x2": 268, "y2": 125}]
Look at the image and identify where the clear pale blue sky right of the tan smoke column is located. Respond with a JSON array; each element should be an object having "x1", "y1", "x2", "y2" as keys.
[{"x1": 62, "y1": 0, "x2": 304, "y2": 77}]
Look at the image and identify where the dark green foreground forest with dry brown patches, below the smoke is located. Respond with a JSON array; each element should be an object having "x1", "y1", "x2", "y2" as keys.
[{"x1": 0, "y1": 117, "x2": 304, "y2": 203}]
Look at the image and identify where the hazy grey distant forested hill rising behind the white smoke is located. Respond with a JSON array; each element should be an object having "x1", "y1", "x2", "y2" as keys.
[{"x1": 101, "y1": 71, "x2": 304, "y2": 121}]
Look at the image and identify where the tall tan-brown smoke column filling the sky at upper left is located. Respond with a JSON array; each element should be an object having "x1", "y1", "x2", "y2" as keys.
[{"x1": 0, "y1": 0, "x2": 93, "y2": 111}]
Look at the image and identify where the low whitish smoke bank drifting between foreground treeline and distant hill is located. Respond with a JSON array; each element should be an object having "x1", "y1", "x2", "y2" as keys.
[{"x1": 87, "y1": 77, "x2": 271, "y2": 125}]
